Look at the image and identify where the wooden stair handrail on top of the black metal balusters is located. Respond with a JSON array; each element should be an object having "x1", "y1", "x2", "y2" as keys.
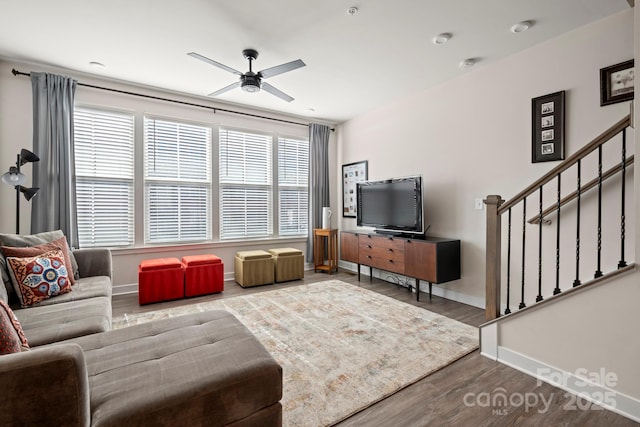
[{"x1": 498, "y1": 114, "x2": 631, "y2": 215}]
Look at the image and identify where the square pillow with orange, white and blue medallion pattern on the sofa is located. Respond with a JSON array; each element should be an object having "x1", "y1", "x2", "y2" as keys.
[{"x1": 7, "y1": 249, "x2": 71, "y2": 307}]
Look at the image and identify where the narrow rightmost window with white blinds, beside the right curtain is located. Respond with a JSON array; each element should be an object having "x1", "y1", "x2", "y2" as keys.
[{"x1": 278, "y1": 137, "x2": 309, "y2": 236}]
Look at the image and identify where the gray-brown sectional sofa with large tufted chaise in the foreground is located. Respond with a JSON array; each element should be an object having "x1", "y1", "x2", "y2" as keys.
[{"x1": 0, "y1": 235, "x2": 282, "y2": 427}]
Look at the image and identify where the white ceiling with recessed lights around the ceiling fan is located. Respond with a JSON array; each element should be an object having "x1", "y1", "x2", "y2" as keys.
[{"x1": 0, "y1": 0, "x2": 630, "y2": 122}]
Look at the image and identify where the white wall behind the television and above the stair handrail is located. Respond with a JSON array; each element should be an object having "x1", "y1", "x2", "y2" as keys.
[{"x1": 336, "y1": 9, "x2": 634, "y2": 307}]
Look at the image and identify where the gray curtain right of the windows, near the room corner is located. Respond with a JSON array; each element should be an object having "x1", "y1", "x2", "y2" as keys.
[{"x1": 307, "y1": 123, "x2": 331, "y2": 262}]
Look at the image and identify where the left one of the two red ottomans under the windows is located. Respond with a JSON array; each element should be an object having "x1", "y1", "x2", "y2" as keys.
[{"x1": 138, "y1": 258, "x2": 184, "y2": 305}]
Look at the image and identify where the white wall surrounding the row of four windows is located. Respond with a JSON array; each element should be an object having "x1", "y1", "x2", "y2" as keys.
[{"x1": 0, "y1": 60, "x2": 336, "y2": 289}]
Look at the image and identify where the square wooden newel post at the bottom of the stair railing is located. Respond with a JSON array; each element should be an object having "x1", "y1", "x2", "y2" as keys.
[{"x1": 484, "y1": 195, "x2": 504, "y2": 320}]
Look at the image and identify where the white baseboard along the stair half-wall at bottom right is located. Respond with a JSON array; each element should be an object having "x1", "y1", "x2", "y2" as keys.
[{"x1": 497, "y1": 347, "x2": 640, "y2": 422}]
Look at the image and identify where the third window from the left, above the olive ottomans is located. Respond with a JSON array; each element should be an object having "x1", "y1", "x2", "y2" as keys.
[{"x1": 219, "y1": 128, "x2": 273, "y2": 239}]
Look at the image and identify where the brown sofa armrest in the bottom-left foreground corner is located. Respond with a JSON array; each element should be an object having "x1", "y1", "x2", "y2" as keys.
[{"x1": 0, "y1": 343, "x2": 91, "y2": 426}]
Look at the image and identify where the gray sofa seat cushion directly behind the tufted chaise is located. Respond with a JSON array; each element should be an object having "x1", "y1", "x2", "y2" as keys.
[{"x1": 15, "y1": 298, "x2": 111, "y2": 347}]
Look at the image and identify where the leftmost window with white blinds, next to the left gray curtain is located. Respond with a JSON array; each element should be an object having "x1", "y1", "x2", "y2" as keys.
[{"x1": 74, "y1": 108, "x2": 134, "y2": 247}]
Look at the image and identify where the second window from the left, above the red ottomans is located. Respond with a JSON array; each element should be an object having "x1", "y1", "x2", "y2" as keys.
[{"x1": 144, "y1": 118, "x2": 211, "y2": 243}]
